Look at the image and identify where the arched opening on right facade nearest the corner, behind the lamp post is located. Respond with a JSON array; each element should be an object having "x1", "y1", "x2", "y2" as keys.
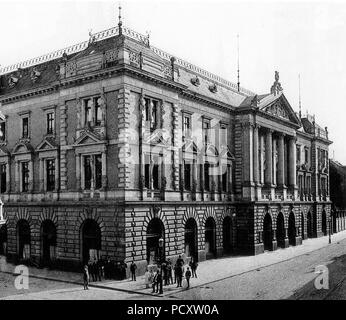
[{"x1": 147, "y1": 218, "x2": 165, "y2": 264}]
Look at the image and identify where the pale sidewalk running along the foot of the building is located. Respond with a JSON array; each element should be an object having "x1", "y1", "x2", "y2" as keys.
[{"x1": 0, "y1": 231, "x2": 346, "y2": 299}]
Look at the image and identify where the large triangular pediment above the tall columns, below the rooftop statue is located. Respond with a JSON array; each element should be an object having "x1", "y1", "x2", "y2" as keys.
[{"x1": 259, "y1": 93, "x2": 301, "y2": 126}]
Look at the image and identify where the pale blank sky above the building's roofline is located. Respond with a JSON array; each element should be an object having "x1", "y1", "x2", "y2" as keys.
[{"x1": 0, "y1": 0, "x2": 346, "y2": 165}]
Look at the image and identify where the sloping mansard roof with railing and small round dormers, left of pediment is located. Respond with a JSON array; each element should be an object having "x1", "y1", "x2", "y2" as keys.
[{"x1": 0, "y1": 28, "x2": 254, "y2": 107}]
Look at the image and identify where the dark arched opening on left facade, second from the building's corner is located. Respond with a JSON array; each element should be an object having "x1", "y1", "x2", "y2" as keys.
[{"x1": 41, "y1": 220, "x2": 56, "y2": 265}]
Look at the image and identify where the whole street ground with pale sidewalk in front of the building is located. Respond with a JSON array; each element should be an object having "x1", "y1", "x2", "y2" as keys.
[{"x1": 0, "y1": 232, "x2": 346, "y2": 300}]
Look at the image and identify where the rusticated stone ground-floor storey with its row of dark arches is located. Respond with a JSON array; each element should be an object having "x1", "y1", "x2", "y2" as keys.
[{"x1": 0, "y1": 204, "x2": 330, "y2": 273}]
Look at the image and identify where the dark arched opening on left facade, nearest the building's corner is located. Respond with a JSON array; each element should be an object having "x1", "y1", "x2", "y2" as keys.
[{"x1": 81, "y1": 219, "x2": 101, "y2": 263}]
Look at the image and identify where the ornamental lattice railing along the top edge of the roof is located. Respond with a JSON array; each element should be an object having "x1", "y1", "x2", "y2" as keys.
[{"x1": 0, "y1": 26, "x2": 255, "y2": 96}]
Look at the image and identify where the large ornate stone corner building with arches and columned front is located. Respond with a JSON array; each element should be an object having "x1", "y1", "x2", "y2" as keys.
[{"x1": 0, "y1": 24, "x2": 331, "y2": 271}]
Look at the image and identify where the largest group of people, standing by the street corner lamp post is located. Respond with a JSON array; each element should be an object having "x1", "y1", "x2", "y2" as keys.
[{"x1": 144, "y1": 256, "x2": 198, "y2": 293}]
